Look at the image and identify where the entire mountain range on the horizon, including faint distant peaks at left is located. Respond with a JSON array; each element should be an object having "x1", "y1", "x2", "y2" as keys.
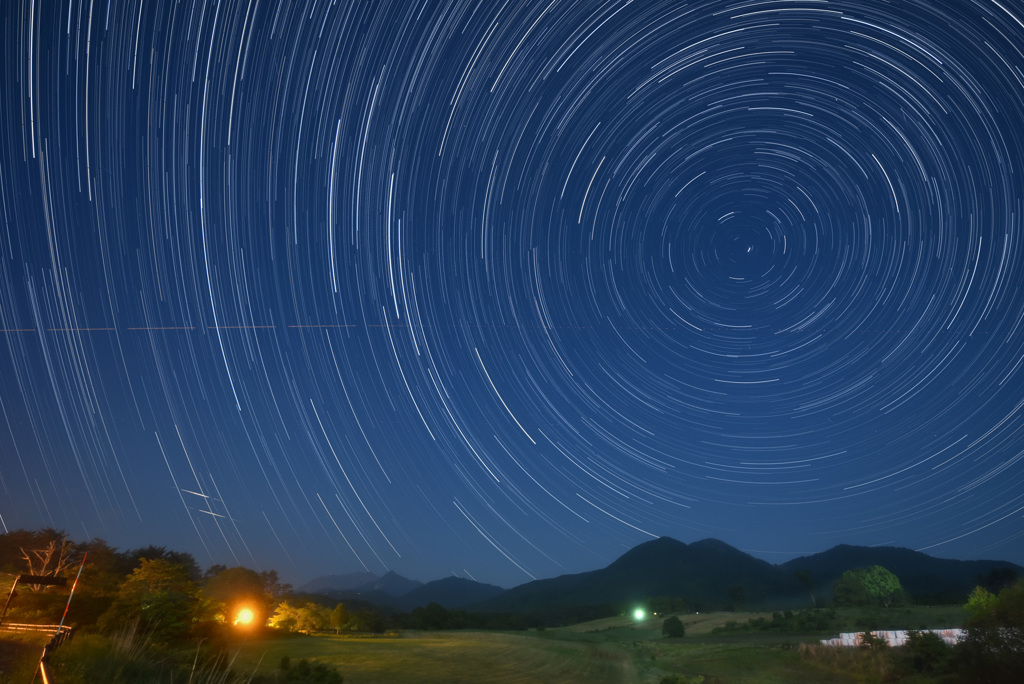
[{"x1": 300, "y1": 537, "x2": 1024, "y2": 613}]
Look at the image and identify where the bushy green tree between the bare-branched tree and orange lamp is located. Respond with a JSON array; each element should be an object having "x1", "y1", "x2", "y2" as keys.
[{"x1": 99, "y1": 558, "x2": 200, "y2": 641}]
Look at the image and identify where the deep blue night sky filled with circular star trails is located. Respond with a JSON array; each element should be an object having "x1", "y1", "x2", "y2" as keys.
[{"x1": 0, "y1": 0, "x2": 1024, "y2": 586}]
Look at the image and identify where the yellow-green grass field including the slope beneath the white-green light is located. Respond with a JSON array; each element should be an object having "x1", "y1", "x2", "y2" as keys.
[{"x1": 220, "y1": 608, "x2": 950, "y2": 684}]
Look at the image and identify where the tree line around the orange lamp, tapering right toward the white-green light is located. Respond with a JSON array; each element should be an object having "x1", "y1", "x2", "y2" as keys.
[{"x1": 0, "y1": 528, "x2": 573, "y2": 643}]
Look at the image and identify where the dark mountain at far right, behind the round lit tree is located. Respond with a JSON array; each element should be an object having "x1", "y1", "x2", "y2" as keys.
[{"x1": 779, "y1": 544, "x2": 1024, "y2": 600}]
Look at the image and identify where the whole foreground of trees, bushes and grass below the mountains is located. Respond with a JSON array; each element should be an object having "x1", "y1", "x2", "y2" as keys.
[{"x1": 0, "y1": 529, "x2": 1024, "y2": 684}]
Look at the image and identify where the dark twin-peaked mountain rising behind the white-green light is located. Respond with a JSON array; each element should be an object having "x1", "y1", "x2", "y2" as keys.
[{"x1": 472, "y1": 537, "x2": 802, "y2": 612}]
